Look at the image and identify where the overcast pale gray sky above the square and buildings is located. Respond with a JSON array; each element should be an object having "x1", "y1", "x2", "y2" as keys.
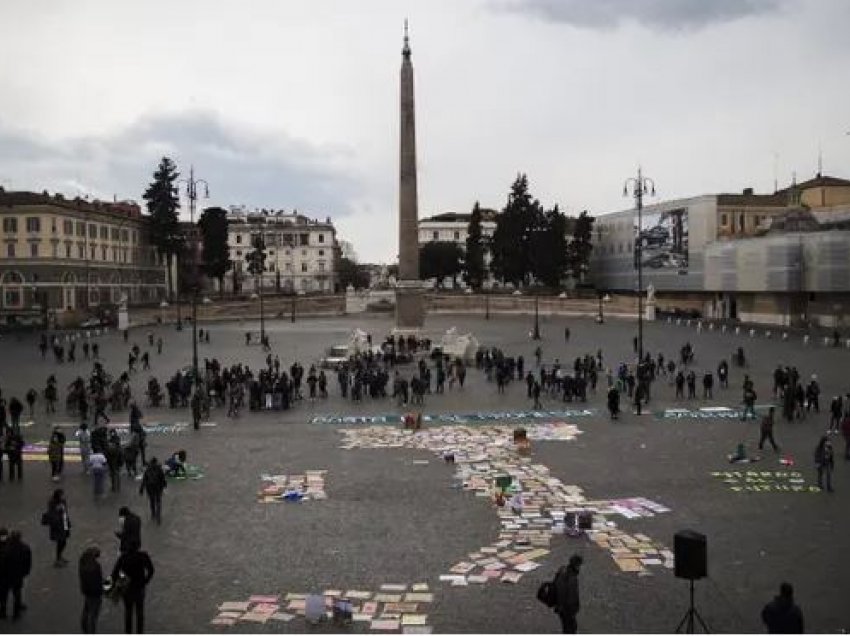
[{"x1": 0, "y1": 0, "x2": 850, "y2": 261}]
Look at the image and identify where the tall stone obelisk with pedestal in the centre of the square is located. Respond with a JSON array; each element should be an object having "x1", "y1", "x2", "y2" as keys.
[{"x1": 395, "y1": 20, "x2": 425, "y2": 331}]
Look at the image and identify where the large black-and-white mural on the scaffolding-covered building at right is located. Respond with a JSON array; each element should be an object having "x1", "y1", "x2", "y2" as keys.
[{"x1": 634, "y1": 208, "x2": 688, "y2": 274}]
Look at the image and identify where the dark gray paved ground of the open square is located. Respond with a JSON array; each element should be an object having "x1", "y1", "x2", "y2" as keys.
[{"x1": 0, "y1": 316, "x2": 850, "y2": 633}]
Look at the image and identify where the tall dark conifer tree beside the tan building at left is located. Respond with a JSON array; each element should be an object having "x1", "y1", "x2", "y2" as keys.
[{"x1": 142, "y1": 157, "x2": 183, "y2": 298}]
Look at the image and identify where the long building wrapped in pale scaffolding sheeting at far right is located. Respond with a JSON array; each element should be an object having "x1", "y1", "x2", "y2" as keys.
[{"x1": 592, "y1": 175, "x2": 850, "y2": 326}]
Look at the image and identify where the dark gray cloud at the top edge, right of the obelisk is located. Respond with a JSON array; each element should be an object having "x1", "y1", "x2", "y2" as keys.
[{"x1": 502, "y1": 0, "x2": 782, "y2": 31}]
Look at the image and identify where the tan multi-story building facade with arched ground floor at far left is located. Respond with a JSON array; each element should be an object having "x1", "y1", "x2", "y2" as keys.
[{"x1": 0, "y1": 191, "x2": 166, "y2": 323}]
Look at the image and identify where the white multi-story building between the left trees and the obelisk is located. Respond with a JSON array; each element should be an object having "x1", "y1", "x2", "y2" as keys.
[{"x1": 225, "y1": 206, "x2": 339, "y2": 293}]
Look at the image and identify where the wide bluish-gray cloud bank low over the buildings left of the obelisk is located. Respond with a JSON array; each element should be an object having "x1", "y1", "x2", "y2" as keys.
[{"x1": 0, "y1": 112, "x2": 360, "y2": 222}]
